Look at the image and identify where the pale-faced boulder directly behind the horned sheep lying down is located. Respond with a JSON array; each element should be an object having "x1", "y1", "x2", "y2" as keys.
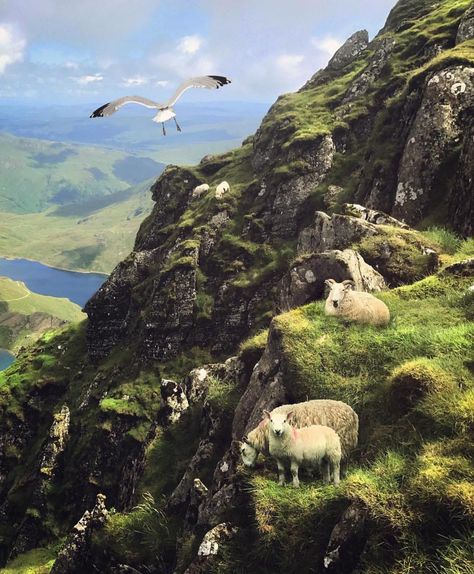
[{"x1": 277, "y1": 249, "x2": 385, "y2": 313}]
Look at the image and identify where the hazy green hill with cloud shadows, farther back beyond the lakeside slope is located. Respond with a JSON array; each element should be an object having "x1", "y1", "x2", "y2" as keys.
[{"x1": 0, "y1": 133, "x2": 164, "y2": 213}]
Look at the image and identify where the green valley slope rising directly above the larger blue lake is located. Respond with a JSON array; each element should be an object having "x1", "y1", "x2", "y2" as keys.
[{"x1": 0, "y1": 180, "x2": 152, "y2": 273}]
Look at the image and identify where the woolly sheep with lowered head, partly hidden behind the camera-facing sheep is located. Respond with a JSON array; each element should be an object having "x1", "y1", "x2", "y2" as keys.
[{"x1": 239, "y1": 399, "x2": 359, "y2": 467}]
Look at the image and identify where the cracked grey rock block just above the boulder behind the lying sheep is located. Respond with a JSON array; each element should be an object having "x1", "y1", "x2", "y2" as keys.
[{"x1": 297, "y1": 211, "x2": 378, "y2": 254}]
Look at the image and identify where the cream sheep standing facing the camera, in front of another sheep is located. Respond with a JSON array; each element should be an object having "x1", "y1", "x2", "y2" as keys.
[{"x1": 263, "y1": 411, "x2": 342, "y2": 488}]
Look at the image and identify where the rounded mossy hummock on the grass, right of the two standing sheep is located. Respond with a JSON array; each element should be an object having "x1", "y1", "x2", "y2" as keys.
[{"x1": 388, "y1": 357, "x2": 455, "y2": 413}]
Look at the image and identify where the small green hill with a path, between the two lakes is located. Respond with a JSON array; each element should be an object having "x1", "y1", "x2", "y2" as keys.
[{"x1": 0, "y1": 277, "x2": 85, "y2": 351}]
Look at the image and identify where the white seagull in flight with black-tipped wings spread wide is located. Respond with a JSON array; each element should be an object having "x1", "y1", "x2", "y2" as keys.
[{"x1": 90, "y1": 76, "x2": 230, "y2": 136}]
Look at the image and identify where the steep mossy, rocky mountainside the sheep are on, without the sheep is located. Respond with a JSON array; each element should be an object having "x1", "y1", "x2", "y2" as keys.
[{"x1": 0, "y1": 0, "x2": 474, "y2": 574}]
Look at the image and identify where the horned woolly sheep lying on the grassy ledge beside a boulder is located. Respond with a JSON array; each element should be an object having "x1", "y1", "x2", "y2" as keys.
[{"x1": 324, "y1": 279, "x2": 390, "y2": 326}]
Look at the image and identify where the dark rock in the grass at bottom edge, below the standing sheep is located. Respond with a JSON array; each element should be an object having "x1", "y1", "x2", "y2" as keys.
[{"x1": 323, "y1": 502, "x2": 368, "y2": 574}]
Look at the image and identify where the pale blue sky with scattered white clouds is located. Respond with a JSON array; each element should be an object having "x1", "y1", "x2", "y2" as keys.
[{"x1": 0, "y1": 0, "x2": 395, "y2": 105}]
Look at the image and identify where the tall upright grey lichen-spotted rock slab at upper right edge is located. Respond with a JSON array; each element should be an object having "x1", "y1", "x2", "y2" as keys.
[{"x1": 392, "y1": 66, "x2": 474, "y2": 224}]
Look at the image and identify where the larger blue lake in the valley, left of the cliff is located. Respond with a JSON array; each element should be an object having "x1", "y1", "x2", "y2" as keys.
[{"x1": 0, "y1": 257, "x2": 107, "y2": 307}]
